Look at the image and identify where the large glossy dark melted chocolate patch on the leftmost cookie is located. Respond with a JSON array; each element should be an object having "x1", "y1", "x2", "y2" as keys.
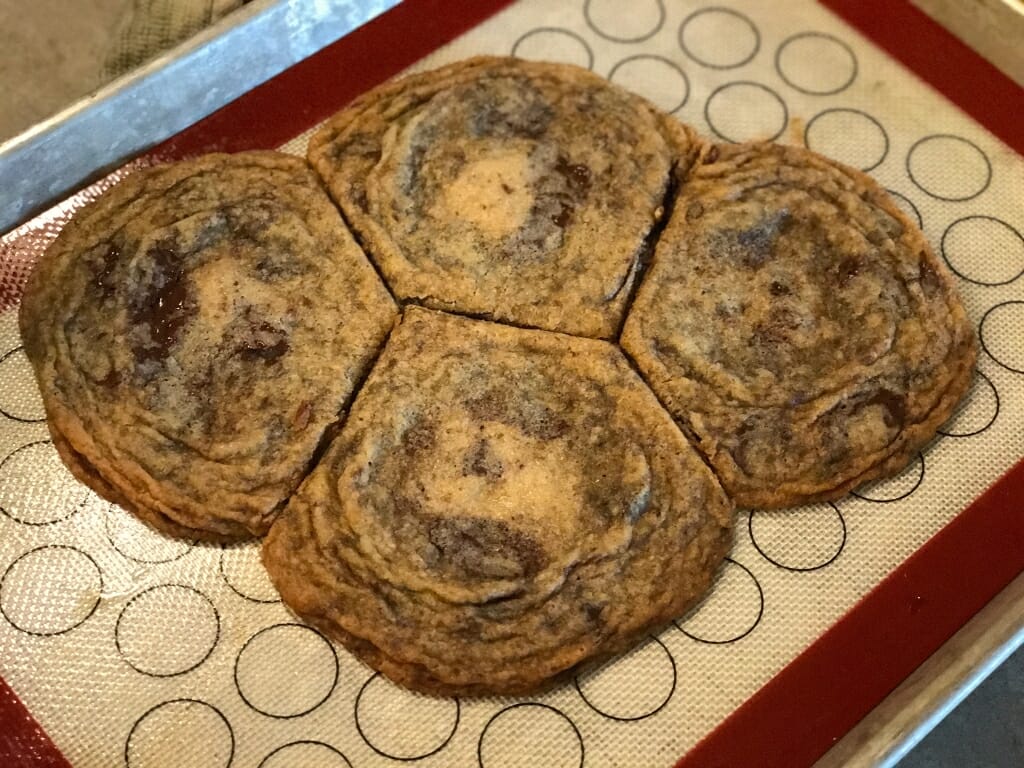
[{"x1": 129, "y1": 245, "x2": 191, "y2": 362}]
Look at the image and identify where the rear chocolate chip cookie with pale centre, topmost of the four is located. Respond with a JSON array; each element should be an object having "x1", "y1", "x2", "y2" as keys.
[{"x1": 309, "y1": 57, "x2": 698, "y2": 338}]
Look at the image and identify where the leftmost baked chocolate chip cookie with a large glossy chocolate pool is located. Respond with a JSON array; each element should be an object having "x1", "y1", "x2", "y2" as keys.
[{"x1": 20, "y1": 152, "x2": 396, "y2": 540}]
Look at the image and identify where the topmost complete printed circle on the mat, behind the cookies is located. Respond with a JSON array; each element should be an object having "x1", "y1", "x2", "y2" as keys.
[{"x1": 679, "y1": 8, "x2": 761, "y2": 70}]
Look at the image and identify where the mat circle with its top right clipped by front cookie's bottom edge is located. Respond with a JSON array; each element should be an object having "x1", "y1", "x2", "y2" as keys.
[{"x1": 355, "y1": 672, "x2": 461, "y2": 760}]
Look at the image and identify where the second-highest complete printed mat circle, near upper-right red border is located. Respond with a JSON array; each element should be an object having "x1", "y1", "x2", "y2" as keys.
[{"x1": 775, "y1": 32, "x2": 857, "y2": 96}]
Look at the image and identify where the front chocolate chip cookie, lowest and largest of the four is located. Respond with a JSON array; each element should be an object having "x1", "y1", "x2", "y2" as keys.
[{"x1": 263, "y1": 307, "x2": 732, "y2": 695}]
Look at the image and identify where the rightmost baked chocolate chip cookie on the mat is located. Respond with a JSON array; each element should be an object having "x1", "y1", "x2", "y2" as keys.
[{"x1": 622, "y1": 143, "x2": 976, "y2": 507}]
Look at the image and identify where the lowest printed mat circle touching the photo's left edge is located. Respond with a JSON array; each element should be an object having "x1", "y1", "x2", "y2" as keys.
[{"x1": 0, "y1": 544, "x2": 103, "y2": 637}]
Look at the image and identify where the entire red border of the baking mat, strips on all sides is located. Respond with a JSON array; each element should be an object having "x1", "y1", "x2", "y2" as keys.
[{"x1": 0, "y1": 0, "x2": 1024, "y2": 768}]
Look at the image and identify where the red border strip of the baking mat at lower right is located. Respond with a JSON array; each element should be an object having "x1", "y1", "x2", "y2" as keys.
[{"x1": 677, "y1": 461, "x2": 1024, "y2": 768}]
